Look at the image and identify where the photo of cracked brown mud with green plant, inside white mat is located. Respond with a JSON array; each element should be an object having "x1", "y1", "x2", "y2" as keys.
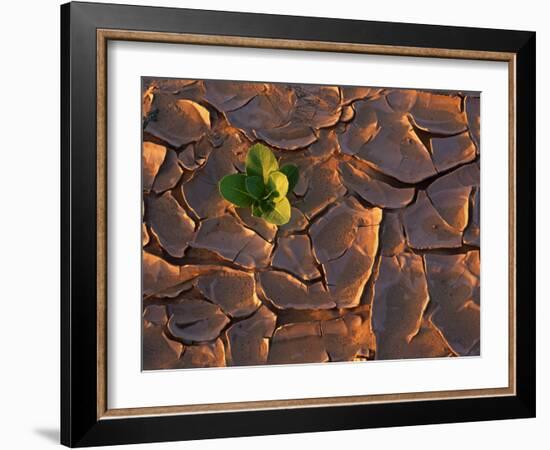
[{"x1": 140, "y1": 77, "x2": 481, "y2": 370}]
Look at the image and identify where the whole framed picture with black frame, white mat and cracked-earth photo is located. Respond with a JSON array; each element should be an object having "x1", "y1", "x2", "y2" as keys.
[{"x1": 61, "y1": 3, "x2": 536, "y2": 447}]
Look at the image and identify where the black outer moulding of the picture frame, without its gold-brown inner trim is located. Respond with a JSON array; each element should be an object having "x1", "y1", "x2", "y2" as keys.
[{"x1": 60, "y1": 3, "x2": 536, "y2": 447}]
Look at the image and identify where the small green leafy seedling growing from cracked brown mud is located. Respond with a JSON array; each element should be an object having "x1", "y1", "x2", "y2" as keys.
[{"x1": 219, "y1": 144, "x2": 298, "y2": 225}]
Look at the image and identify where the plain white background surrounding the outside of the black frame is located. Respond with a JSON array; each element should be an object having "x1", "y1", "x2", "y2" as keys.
[{"x1": 0, "y1": 0, "x2": 550, "y2": 450}]
